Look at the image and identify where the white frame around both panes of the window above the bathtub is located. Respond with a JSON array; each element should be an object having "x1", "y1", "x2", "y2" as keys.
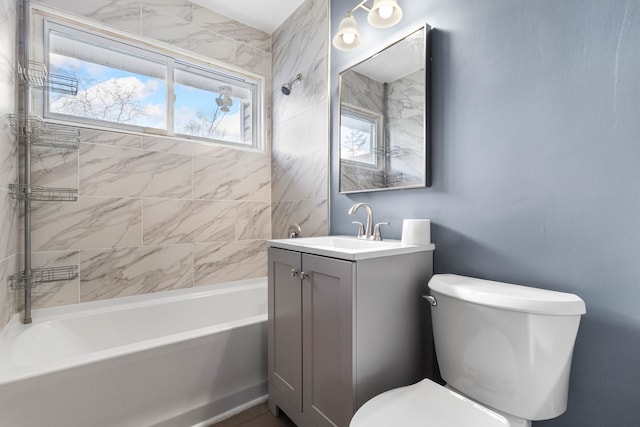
[{"x1": 32, "y1": 9, "x2": 266, "y2": 151}]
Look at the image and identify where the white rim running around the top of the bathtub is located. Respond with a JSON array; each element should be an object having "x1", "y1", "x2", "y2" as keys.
[{"x1": 0, "y1": 277, "x2": 267, "y2": 387}]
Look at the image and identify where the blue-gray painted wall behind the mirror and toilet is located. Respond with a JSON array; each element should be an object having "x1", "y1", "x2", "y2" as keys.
[{"x1": 330, "y1": 0, "x2": 640, "y2": 426}]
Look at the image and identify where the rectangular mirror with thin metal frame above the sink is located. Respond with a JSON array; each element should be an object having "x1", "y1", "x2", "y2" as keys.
[{"x1": 339, "y1": 25, "x2": 431, "y2": 193}]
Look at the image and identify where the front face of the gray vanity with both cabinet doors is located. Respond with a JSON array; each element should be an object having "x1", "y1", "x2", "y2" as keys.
[{"x1": 269, "y1": 248, "x2": 354, "y2": 427}]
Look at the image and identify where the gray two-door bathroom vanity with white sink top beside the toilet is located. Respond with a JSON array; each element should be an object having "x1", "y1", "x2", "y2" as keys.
[{"x1": 268, "y1": 236, "x2": 434, "y2": 427}]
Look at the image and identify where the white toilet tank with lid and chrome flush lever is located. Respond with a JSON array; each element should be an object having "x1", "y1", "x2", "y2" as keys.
[{"x1": 429, "y1": 274, "x2": 586, "y2": 420}]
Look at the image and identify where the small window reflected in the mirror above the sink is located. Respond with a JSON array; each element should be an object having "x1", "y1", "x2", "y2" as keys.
[{"x1": 340, "y1": 105, "x2": 383, "y2": 167}]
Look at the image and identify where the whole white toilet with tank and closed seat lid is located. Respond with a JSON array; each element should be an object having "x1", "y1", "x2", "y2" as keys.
[{"x1": 350, "y1": 274, "x2": 586, "y2": 427}]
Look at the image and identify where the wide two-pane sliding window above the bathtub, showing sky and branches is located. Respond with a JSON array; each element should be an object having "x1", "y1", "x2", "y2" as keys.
[{"x1": 44, "y1": 20, "x2": 262, "y2": 148}]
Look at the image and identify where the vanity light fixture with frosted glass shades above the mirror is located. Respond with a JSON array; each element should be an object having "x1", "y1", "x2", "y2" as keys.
[{"x1": 333, "y1": 0, "x2": 402, "y2": 50}]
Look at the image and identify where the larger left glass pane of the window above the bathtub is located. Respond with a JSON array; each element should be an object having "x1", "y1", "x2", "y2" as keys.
[{"x1": 49, "y1": 30, "x2": 167, "y2": 129}]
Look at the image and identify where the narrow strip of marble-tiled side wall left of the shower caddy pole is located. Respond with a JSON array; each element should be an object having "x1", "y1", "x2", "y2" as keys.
[{"x1": 0, "y1": 0, "x2": 18, "y2": 329}]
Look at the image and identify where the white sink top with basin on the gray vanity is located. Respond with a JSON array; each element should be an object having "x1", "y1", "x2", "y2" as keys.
[{"x1": 269, "y1": 236, "x2": 434, "y2": 261}]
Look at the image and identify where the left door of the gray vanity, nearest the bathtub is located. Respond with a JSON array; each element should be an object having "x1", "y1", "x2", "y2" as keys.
[{"x1": 268, "y1": 248, "x2": 302, "y2": 412}]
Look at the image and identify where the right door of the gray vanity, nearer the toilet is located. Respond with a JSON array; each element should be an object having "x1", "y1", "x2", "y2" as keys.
[{"x1": 302, "y1": 254, "x2": 355, "y2": 427}]
